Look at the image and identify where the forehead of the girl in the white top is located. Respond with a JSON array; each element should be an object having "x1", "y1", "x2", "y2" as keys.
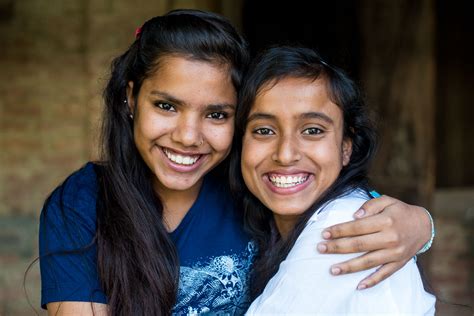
[{"x1": 250, "y1": 77, "x2": 341, "y2": 118}]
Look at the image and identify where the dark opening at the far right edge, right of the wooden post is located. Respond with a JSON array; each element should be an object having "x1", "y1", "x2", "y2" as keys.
[{"x1": 435, "y1": 0, "x2": 474, "y2": 187}]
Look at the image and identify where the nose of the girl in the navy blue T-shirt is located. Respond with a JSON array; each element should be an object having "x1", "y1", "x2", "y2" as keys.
[{"x1": 171, "y1": 115, "x2": 203, "y2": 147}]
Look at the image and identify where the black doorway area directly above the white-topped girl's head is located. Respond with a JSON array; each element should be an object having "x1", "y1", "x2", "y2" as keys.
[{"x1": 243, "y1": 0, "x2": 359, "y2": 79}]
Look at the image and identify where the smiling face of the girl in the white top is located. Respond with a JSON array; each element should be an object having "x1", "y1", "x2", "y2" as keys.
[{"x1": 241, "y1": 77, "x2": 351, "y2": 235}]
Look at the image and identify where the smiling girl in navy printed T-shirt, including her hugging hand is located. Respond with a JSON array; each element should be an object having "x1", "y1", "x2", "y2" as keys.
[{"x1": 39, "y1": 10, "x2": 436, "y2": 315}]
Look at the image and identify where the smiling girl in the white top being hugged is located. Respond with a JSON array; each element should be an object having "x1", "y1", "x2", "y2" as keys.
[{"x1": 231, "y1": 46, "x2": 435, "y2": 315}]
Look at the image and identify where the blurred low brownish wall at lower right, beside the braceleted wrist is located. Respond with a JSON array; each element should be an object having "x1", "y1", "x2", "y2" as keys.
[{"x1": 428, "y1": 188, "x2": 474, "y2": 315}]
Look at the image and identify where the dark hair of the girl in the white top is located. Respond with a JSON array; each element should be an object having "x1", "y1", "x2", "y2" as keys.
[{"x1": 230, "y1": 46, "x2": 376, "y2": 298}]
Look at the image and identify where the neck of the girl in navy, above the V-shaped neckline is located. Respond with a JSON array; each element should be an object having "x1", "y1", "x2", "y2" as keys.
[{"x1": 154, "y1": 179, "x2": 203, "y2": 232}]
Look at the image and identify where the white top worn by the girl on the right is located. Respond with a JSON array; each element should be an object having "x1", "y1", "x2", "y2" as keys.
[{"x1": 247, "y1": 191, "x2": 436, "y2": 315}]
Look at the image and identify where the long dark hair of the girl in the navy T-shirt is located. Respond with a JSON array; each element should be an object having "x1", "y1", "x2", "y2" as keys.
[{"x1": 38, "y1": 10, "x2": 249, "y2": 315}]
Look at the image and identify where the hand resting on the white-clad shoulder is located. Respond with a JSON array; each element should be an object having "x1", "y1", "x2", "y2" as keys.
[{"x1": 317, "y1": 195, "x2": 432, "y2": 290}]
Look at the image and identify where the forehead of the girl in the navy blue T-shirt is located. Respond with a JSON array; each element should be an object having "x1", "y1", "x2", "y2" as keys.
[{"x1": 141, "y1": 55, "x2": 236, "y2": 104}]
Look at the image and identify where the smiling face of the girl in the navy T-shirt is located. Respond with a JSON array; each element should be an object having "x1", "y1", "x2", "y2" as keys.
[{"x1": 127, "y1": 55, "x2": 237, "y2": 198}]
